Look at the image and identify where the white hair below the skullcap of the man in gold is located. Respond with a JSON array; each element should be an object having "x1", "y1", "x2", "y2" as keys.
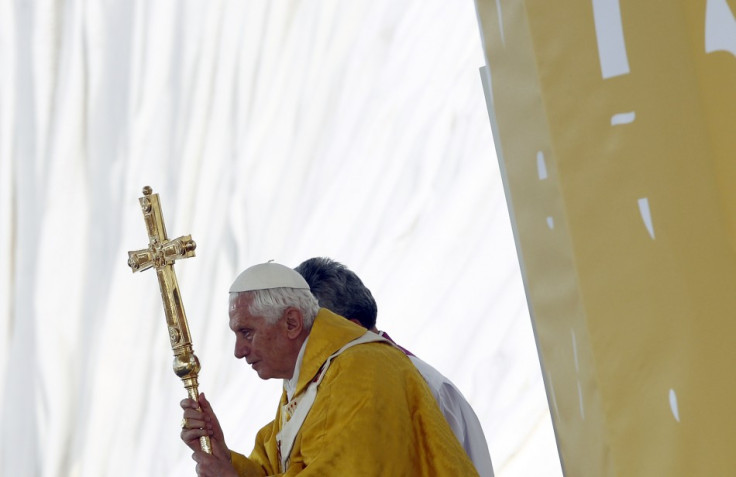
[{"x1": 241, "y1": 288, "x2": 319, "y2": 330}]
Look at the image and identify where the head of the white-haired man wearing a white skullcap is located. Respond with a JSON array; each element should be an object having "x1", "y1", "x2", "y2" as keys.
[{"x1": 229, "y1": 262, "x2": 319, "y2": 379}]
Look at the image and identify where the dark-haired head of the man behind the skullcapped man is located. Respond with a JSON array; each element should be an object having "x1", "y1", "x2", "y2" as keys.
[{"x1": 294, "y1": 257, "x2": 378, "y2": 330}]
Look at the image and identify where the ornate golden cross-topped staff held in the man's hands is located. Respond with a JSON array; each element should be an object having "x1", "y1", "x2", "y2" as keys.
[{"x1": 128, "y1": 186, "x2": 212, "y2": 454}]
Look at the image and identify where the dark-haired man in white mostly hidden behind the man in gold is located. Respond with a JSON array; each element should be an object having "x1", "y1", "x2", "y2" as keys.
[{"x1": 295, "y1": 257, "x2": 493, "y2": 477}]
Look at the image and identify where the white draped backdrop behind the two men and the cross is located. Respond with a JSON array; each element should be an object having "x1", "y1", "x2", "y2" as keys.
[{"x1": 0, "y1": 0, "x2": 561, "y2": 477}]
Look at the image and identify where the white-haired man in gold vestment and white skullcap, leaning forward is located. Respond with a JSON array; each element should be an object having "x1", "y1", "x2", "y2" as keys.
[{"x1": 181, "y1": 263, "x2": 477, "y2": 477}]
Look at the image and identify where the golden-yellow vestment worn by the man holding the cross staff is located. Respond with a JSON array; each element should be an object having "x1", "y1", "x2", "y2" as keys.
[{"x1": 227, "y1": 308, "x2": 477, "y2": 477}]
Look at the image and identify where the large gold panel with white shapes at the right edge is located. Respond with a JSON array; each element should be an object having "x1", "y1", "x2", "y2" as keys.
[{"x1": 476, "y1": 0, "x2": 736, "y2": 477}]
